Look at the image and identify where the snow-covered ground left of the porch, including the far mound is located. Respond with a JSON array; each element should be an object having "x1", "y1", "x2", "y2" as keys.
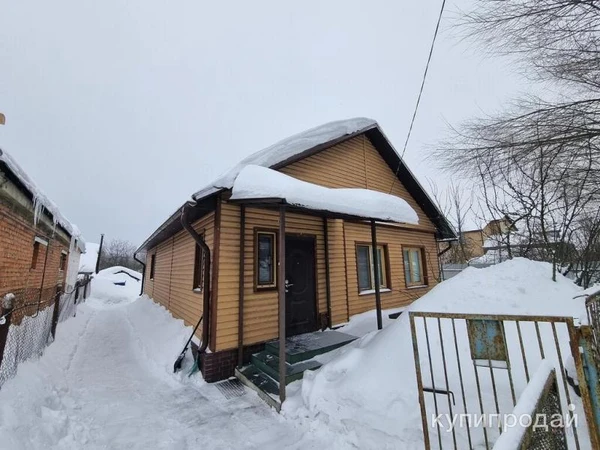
[{"x1": 0, "y1": 270, "x2": 348, "y2": 450}]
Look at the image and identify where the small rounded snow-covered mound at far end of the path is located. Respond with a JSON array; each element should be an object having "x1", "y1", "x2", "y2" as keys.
[{"x1": 92, "y1": 266, "x2": 142, "y2": 304}]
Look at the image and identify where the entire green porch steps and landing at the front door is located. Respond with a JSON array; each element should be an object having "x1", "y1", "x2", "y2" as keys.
[{"x1": 235, "y1": 330, "x2": 357, "y2": 410}]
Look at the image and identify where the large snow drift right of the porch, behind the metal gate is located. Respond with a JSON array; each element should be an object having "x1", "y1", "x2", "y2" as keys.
[{"x1": 283, "y1": 258, "x2": 585, "y2": 450}]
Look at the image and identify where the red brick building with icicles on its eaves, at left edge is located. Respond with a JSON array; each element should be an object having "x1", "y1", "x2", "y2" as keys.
[{"x1": 0, "y1": 150, "x2": 85, "y2": 325}]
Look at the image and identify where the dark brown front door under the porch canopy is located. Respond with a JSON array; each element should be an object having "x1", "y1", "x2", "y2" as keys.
[{"x1": 285, "y1": 236, "x2": 317, "y2": 336}]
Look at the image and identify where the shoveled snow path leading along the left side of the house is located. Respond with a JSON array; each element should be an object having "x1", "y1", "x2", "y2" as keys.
[{"x1": 0, "y1": 301, "x2": 343, "y2": 450}]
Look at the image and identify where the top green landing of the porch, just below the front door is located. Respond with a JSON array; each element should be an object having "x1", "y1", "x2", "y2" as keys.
[{"x1": 265, "y1": 330, "x2": 356, "y2": 370}]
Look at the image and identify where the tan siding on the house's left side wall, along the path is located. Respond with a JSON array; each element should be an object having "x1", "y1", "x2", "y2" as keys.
[{"x1": 144, "y1": 213, "x2": 214, "y2": 334}]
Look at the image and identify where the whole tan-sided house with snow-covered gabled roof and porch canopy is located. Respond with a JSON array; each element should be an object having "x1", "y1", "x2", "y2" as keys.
[{"x1": 136, "y1": 119, "x2": 456, "y2": 381}]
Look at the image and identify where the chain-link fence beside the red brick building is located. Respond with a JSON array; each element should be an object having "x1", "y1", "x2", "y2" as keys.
[{"x1": 0, "y1": 277, "x2": 90, "y2": 387}]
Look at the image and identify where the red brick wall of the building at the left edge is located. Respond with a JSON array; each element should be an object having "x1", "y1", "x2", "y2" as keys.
[{"x1": 0, "y1": 204, "x2": 69, "y2": 323}]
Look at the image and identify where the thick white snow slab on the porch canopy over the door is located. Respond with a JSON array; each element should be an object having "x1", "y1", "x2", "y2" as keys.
[{"x1": 231, "y1": 165, "x2": 419, "y2": 225}]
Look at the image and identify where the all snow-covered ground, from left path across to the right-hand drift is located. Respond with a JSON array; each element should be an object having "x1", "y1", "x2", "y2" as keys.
[{"x1": 0, "y1": 259, "x2": 589, "y2": 450}]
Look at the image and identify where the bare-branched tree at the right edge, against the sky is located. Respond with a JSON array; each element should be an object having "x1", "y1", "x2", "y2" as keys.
[{"x1": 436, "y1": 0, "x2": 600, "y2": 284}]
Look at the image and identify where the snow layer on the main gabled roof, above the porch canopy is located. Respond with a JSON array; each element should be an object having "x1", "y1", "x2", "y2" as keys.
[{"x1": 192, "y1": 117, "x2": 377, "y2": 200}]
